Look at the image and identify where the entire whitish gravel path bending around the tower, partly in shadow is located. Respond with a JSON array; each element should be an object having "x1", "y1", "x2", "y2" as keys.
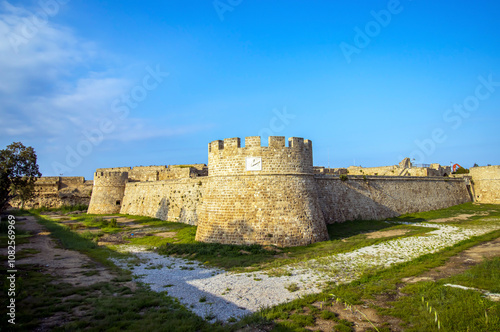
[{"x1": 111, "y1": 223, "x2": 500, "y2": 321}]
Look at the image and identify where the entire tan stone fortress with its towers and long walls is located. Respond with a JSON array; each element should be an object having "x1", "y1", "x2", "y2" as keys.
[{"x1": 79, "y1": 136, "x2": 500, "y2": 246}]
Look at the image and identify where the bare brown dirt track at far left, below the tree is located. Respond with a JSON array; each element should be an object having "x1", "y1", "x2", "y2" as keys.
[{"x1": 12, "y1": 216, "x2": 115, "y2": 286}]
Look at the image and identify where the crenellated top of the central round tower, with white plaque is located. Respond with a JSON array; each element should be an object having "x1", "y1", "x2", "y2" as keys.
[{"x1": 208, "y1": 136, "x2": 313, "y2": 176}]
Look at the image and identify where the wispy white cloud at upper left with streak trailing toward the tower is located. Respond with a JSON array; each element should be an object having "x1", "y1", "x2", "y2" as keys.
[{"x1": 0, "y1": 0, "x2": 210, "y2": 174}]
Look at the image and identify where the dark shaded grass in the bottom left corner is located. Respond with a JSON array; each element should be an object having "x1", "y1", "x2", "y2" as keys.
[{"x1": 0, "y1": 265, "x2": 225, "y2": 331}]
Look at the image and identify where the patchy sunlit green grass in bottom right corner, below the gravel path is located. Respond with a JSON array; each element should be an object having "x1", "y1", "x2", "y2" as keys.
[{"x1": 237, "y1": 230, "x2": 500, "y2": 331}]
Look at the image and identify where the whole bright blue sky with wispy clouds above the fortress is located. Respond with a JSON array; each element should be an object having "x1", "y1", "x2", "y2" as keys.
[{"x1": 0, "y1": 0, "x2": 500, "y2": 178}]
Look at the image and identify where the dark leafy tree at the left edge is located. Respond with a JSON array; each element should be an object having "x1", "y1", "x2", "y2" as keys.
[{"x1": 0, "y1": 142, "x2": 42, "y2": 211}]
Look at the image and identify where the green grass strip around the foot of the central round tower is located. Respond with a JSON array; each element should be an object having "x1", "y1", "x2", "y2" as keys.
[{"x1": 157, "y1": 220, "x2": 432, "y2": 271}]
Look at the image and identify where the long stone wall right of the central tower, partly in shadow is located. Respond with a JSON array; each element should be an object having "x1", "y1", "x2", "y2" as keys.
[{"x1": 316, "y1": 176, "x2": 471, "y2": 223}]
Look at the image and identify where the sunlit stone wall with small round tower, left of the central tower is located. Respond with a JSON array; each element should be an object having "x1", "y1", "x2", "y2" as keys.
[{"x1": 88, "y1": 164, "x2": 208, "y2": 217}]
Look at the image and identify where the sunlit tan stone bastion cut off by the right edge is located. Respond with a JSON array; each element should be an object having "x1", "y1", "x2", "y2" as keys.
[{"x1": 469, "y1": 165, "x2": 500, "y2": 204}]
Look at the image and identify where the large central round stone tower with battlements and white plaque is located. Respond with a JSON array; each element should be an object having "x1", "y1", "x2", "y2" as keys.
[{"x1": 196, "y1": 137, "x2": 328, "y2": 246}]
